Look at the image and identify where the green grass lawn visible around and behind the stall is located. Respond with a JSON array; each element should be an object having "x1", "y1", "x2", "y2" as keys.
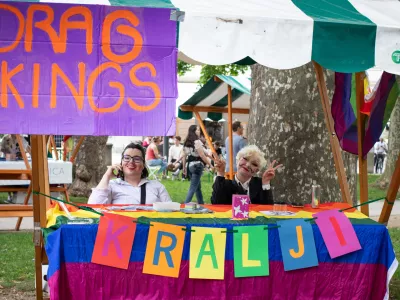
[{"x1": 0, "y1": 174, "x2": 400, "y2": 299}]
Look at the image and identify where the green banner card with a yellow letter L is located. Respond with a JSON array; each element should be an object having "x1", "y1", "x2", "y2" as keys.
[{"x1": 233, "y1": 226, "x2": 269, "y2": 277}]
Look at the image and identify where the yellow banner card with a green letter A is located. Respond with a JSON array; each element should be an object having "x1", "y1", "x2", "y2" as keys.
[{"x1": 189, "y1": 227, "x2": 226, "y2": 279}]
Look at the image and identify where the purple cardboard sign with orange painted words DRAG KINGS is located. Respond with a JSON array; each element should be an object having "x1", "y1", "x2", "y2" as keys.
[{"x1": 0, "y1": 2, "x2": 177, "y2": 136}]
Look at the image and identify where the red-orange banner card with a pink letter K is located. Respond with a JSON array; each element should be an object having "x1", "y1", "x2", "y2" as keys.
[{"x1": 92, "y1": 213, "x2": 136, "y2": 269}]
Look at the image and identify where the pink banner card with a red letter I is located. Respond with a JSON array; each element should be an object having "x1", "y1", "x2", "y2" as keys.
[{"x1": 313, "y1": 210, "x2": 361, "y2": 258}]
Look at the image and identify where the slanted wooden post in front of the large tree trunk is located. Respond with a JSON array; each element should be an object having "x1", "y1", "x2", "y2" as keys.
[{"x1": 313, "y1": 61, "x2": 353, "y2": 205}]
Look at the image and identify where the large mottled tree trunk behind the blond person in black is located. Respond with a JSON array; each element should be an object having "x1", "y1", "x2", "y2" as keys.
[{"x1": 248, "y1": 63, "x2": 357, "y2": 204}]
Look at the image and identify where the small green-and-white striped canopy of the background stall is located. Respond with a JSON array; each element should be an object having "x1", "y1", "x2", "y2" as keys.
[{"x1": 178, "y1": 75, "x2": 251, "y2": 121}]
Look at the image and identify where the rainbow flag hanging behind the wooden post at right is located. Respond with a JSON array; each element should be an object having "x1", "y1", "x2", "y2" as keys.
[{"x1": 331, "y1": 72, "x2": 399, "y2": 156}]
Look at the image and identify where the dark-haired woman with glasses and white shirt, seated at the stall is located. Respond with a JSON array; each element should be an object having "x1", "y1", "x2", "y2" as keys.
[{"x1": 88, "y1": 143, "x2": 171, "y2": 204}]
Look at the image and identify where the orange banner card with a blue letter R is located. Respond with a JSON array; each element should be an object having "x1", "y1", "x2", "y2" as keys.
[{"x1": 143, "y1": 222, "x2": 185, "y2": 278}]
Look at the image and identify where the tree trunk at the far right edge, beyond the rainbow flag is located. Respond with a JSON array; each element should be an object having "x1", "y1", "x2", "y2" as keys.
[{"x1": 375, "y1": 76, "x2": 400, "y2": 189}]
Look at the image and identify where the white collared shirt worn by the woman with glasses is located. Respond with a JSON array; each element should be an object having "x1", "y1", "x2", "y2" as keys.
[{"x1": 88, "y1": 178, "x2": 171, "y2": 204}]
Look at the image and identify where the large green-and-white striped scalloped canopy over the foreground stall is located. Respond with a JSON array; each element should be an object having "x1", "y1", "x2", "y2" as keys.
[{"x1": 11, "y1": 0, "x2": 400, "y2": 74}]
